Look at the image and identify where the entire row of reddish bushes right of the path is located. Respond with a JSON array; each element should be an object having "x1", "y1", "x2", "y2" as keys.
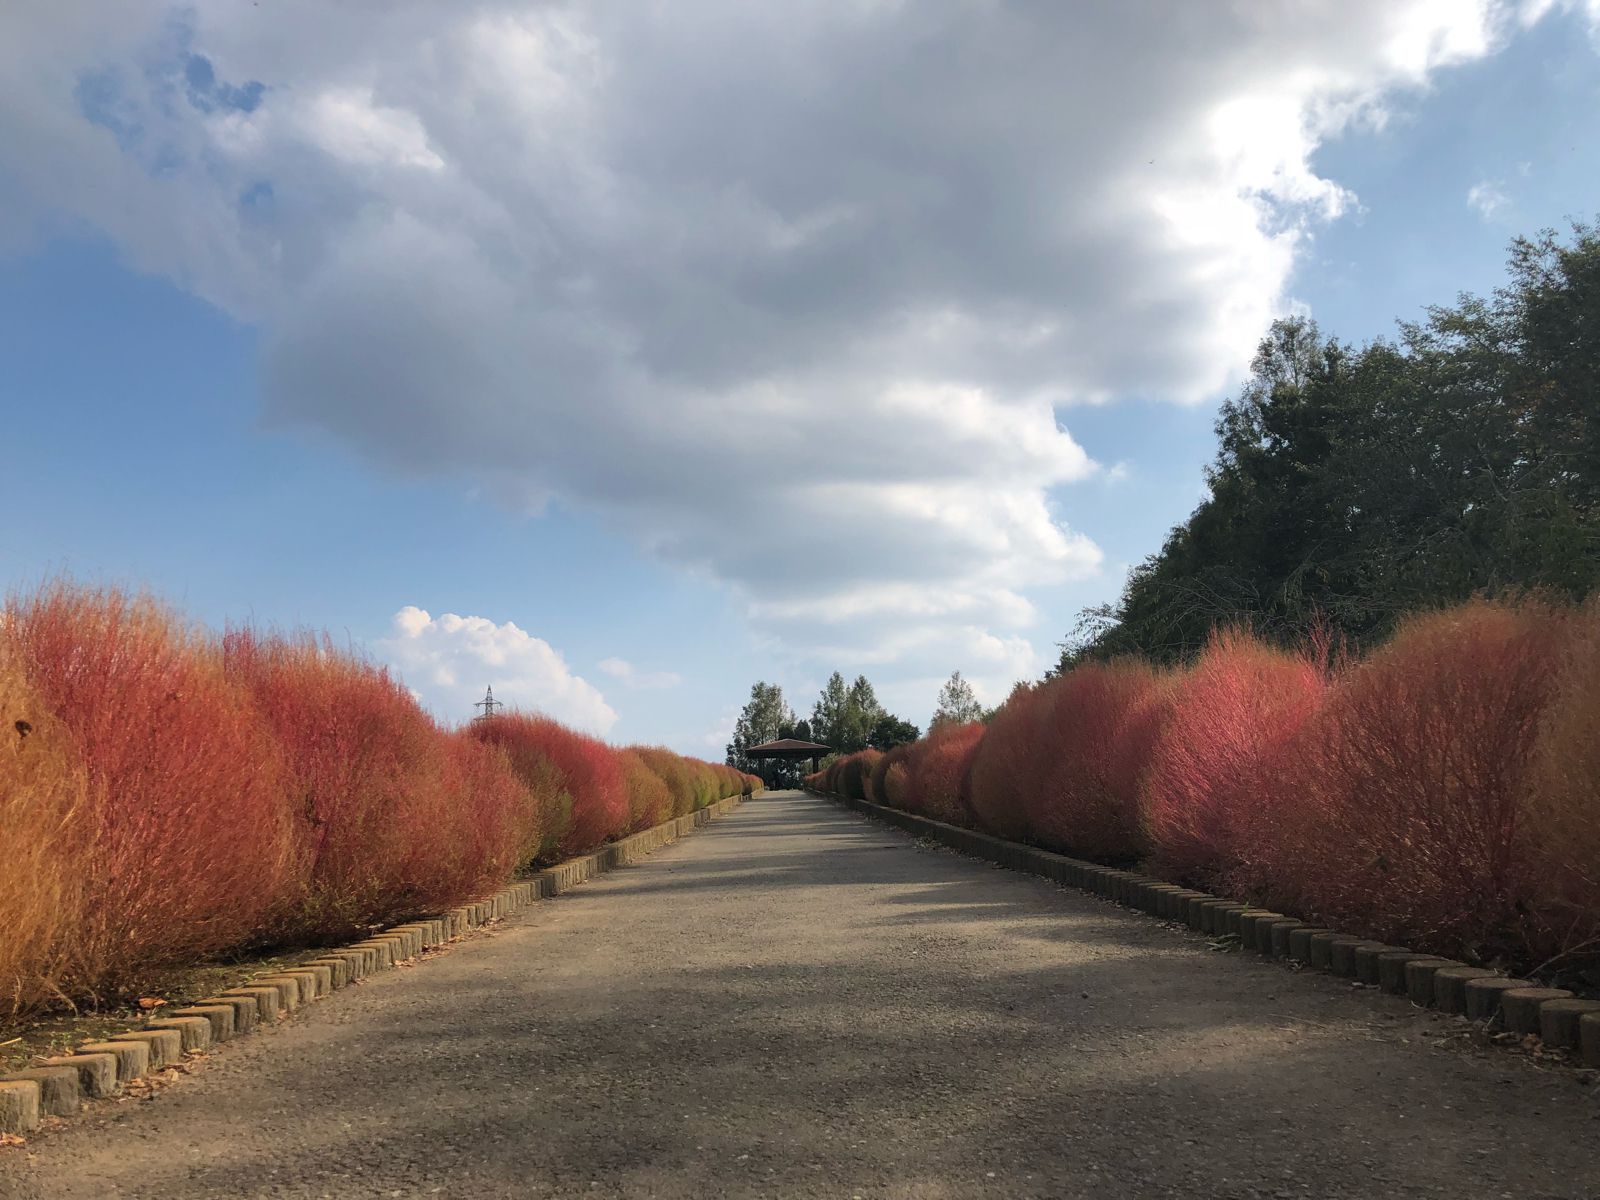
[{"x1": 811, "y1": 600, "x2": 1600, "y2": 970}]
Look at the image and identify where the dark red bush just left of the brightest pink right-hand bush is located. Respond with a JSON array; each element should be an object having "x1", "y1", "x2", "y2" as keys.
[{"x1": 1030, "y1": 659, "x2": 1168, "y2": 861}]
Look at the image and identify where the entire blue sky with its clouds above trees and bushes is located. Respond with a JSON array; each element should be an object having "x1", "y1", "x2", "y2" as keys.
[{"x1": 0, "y1": 0, "x2": 1600, "y2": 754}]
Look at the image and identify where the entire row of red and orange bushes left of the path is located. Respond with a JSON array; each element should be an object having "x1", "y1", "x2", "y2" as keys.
[{"x1": 0, "y1": 584, "x2": 760, "y2": 1018}]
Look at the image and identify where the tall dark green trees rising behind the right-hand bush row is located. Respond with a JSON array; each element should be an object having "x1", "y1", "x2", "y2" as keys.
[{"x1": 1058, "y1": 224, "x2": 1600, "y2": 670}]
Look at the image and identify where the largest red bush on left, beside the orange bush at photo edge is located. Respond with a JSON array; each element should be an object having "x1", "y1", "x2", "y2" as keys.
[{"x1": 3, "y1": 584, "x2": 290, "y2": 995}]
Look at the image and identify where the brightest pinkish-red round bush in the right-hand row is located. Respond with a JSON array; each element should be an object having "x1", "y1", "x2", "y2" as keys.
[{"x1": 1142, "y1": 630, "x2": 1326, "y2": 883}]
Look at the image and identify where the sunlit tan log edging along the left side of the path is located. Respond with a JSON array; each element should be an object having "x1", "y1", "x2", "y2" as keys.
[{"x1": 0, "y1": 795, "x2": 746, "y2": 1134}]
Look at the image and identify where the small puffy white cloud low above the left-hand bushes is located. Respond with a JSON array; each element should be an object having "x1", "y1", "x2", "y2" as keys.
[{"x1": 378, "y1": 605, "x2": 616, "y2": 734}]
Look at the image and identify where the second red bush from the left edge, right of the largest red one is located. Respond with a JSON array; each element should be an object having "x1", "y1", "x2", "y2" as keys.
[{"x1": 222, "y1": 629, "x2": 472, "y2": 941}]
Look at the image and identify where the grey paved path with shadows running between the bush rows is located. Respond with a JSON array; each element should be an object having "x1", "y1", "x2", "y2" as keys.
[{"x1": 0, "y1": 792, "x2": 1600, "y2": 1200}]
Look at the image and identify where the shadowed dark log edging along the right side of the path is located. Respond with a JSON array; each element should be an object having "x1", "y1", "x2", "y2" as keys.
[{"x1": 806, "y1": 787, "x2": 1600, "y2": 1067}]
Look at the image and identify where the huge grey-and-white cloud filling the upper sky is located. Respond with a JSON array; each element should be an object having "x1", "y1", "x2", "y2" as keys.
[{"x1": 0, "y1": 0, "x2": 1542, "y2": 678}]
